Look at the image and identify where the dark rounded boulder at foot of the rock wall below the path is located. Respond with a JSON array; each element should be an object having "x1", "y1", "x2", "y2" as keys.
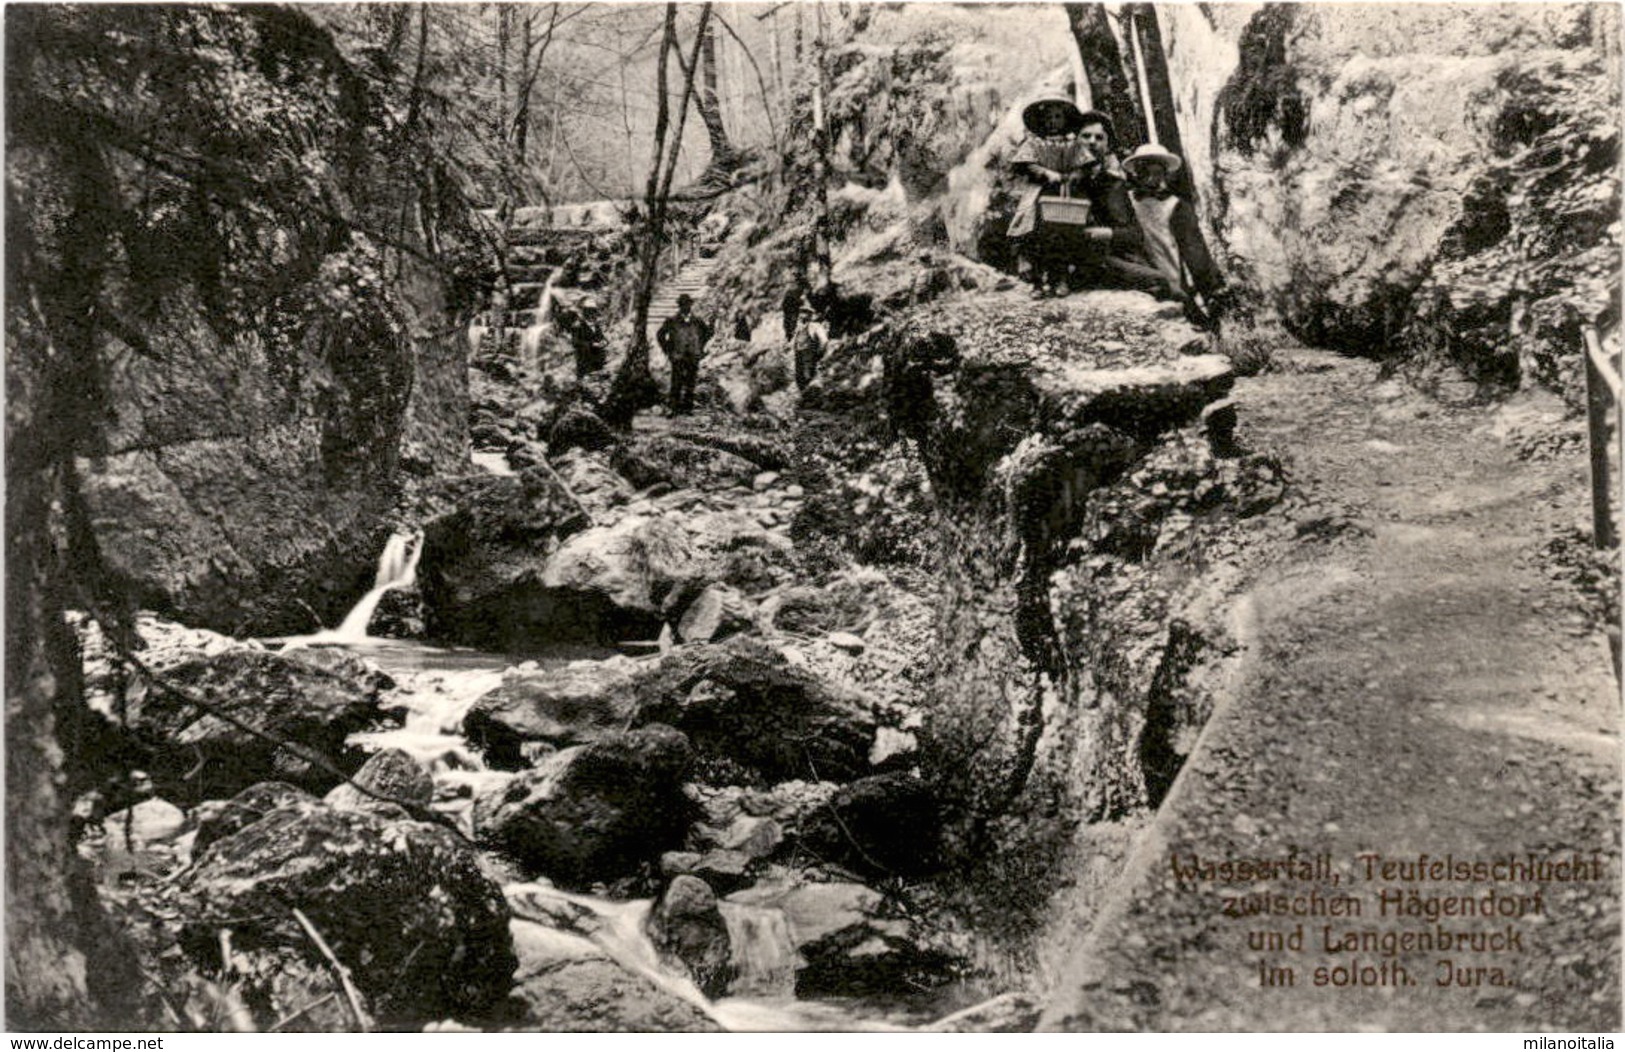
[{"x1": 798, "y1": 774, "x2": 941, "y2": 878}]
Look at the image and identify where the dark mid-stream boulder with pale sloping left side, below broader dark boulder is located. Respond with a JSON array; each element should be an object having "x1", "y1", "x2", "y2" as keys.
[{"x1": 475, "y1": 725, "x2": 692, "y2": 888}]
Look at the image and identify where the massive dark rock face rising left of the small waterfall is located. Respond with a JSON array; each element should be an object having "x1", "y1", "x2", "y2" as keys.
[{"x1": 7, "y1": 8, "x2": 466, "y2": 634}]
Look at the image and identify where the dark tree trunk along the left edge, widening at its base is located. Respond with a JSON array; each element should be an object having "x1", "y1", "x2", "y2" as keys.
[{"x1": 5, "y1": 269, "x2": 140, "y2": 1029}]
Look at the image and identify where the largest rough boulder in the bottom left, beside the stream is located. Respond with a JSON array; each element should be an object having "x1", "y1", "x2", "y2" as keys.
[{"x1": 150, "y1": 800, "x2": 515, "y2": 1028}]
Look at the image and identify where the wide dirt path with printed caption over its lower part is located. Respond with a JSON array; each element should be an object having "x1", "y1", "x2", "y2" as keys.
[{"x1": 1043, "y1": 351, "x2": 1620, "y2": 1031}]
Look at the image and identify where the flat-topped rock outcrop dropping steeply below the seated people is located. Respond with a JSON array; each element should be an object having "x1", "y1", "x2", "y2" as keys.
[{"x1": 851, "y1": 276, "x2": 1282, "y2": 961}]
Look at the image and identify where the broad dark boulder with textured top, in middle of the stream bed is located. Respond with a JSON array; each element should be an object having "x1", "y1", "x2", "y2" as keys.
[{"x1": 634, "y1": 637, "x2": 876, "y2": 782}]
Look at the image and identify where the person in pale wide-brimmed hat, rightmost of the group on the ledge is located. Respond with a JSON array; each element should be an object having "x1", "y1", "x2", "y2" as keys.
[{"x1": 1123, "y1": 143, "x2": 1224, "y2": 320}]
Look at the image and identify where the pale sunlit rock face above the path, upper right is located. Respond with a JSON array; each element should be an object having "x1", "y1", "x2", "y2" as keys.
[{"x1": 1157, "y1": 3, "x2": 1620, "y2": 384}]
